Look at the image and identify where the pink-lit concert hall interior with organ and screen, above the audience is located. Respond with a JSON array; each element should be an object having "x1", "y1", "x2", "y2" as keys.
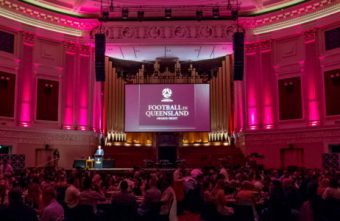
[{"x1": 0, "y1": 0, "x2": 340, "y2": 219}]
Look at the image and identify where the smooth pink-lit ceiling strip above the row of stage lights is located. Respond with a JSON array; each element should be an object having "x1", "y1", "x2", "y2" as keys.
[{"x1": 21, "y1": 0, "x2": 306, "y2": 17}]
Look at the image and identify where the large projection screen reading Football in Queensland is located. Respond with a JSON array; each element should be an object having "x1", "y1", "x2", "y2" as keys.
[{"x1": 125, "y1": 84, "x2": 210, "y2": 132}]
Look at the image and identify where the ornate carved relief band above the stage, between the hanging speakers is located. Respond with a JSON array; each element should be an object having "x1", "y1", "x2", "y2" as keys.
[{"x1": 90, "y1": 21, "x2": 236, "y2": 43}]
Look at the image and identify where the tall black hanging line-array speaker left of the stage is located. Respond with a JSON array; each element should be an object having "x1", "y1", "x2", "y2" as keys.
[{"x1": 94, "y1": 34, "x2": 105, "y2": 81}]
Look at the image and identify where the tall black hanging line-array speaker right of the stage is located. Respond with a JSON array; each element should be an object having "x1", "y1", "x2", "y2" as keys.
[{"x1": 233, "y1": 32, "x2": 244, "y2": 81}]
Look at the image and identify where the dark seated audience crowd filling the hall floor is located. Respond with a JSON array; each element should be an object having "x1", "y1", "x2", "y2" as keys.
[{"x1": 0, "y1": 162, "x2": 340, "y2": 221}]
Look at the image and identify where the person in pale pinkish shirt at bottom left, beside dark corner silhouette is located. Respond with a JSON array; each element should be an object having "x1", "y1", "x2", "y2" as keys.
[{"x1": 40, "y1": 185, "x2": 64, "y2": 221}]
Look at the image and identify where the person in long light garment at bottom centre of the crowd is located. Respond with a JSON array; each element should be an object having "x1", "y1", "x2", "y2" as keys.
[{"x1": 160, "y1": 176, "x2": 177, "y2": 221}]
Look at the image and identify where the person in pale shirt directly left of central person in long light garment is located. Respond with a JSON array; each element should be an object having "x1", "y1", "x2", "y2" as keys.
[{"x1": 138, "y1": 175, "x2": 161, "y2": 217}]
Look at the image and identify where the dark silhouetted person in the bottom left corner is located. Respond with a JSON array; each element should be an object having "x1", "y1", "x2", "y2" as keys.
[{"x1": 0, "y1": 189, "x2": 38, "y2": 221}]
